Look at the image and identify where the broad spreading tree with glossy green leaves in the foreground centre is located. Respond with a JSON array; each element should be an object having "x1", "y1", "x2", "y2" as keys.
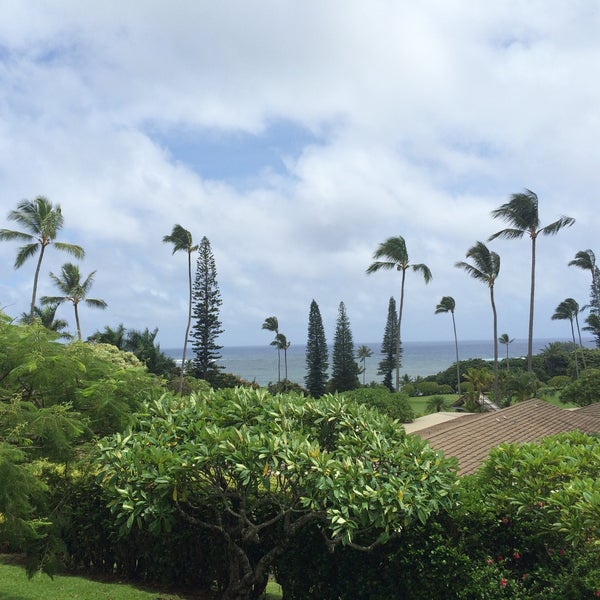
[{"x1": 98, "y1": 388, "x2": 455, "y2": 598}]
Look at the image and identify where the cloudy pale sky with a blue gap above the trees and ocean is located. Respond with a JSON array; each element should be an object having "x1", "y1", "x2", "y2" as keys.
[{"x1": 0, "y1": 0, "x2": 600, "y2": 349}]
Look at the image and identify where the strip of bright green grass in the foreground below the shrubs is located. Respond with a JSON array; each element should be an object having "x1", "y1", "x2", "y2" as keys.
[{"x1": 0, "y1": 555, "x2": 281, "y2": 600}]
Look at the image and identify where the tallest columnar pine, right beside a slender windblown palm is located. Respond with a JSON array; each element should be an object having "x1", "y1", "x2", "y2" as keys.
[{"x1": 192, "y1": 236, "x2": 223, "y2": 379}]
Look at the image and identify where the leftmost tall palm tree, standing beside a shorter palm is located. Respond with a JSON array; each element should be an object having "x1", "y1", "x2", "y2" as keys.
[{"x1": 0, "y1": 196, "x2": 85, "y2": 320}]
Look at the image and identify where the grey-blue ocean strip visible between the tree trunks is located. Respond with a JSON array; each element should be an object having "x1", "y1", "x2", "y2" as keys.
[{"x1": 163, "y1": 339, "x2": 594, "y2": 386}]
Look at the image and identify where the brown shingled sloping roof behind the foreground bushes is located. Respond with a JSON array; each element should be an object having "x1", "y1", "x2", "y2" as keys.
[{"x1": 413, "y1": 398, "x2": 600, "y2": 475}]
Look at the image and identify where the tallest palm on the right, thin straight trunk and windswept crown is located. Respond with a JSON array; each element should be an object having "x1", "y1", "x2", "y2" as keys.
[{"x1": 488, "y1": 189, "x2": 575, "y2": 371}]
